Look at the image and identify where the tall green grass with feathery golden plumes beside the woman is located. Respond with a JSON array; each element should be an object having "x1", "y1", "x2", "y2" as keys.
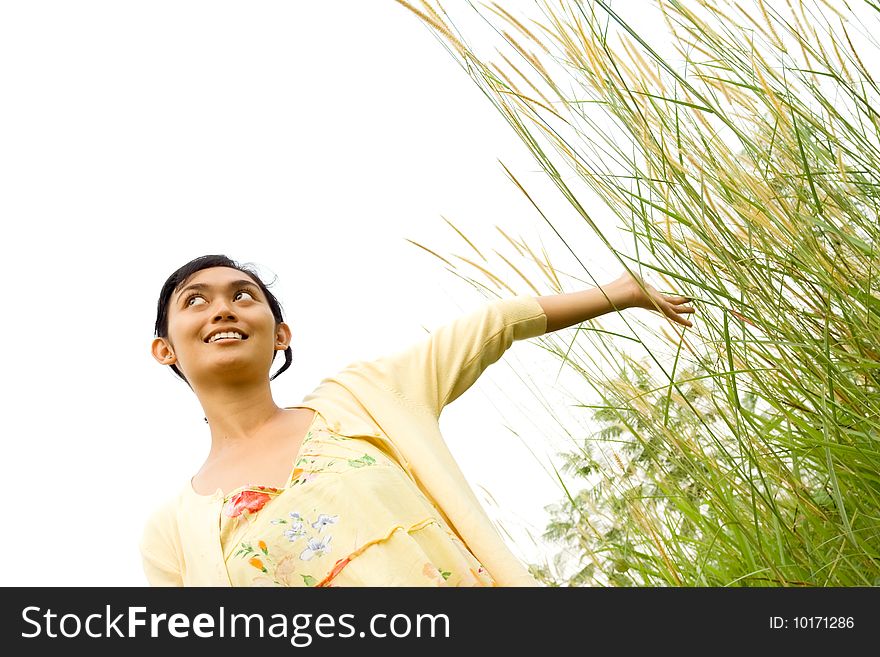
[{"x1": 403, "y1": 0, "x2": 880, "y2": 586}]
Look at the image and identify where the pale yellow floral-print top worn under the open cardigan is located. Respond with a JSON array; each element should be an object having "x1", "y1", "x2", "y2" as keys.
[{"x1": 189, "y1": 412, "x2": 495, "y2": 586}]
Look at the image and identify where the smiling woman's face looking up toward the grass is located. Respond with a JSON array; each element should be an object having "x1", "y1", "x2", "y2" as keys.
[{"x1": 153, "y1": 267, "x2": 290, "y2": 384}]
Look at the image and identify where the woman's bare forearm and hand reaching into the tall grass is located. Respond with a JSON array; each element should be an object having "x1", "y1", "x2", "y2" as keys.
[{"x1": 535, "y1": 272, "x2": 694, "y2": 333}]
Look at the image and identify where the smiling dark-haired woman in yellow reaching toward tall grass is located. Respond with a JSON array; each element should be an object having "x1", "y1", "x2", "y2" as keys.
[{"x1": 141, "y1": 255, "x2": 694, "y2": 586}]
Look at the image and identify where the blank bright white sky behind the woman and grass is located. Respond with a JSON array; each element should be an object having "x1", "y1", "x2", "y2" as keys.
[{"x1": 0, "y1": 0, "x2": 860, "y2": 586}]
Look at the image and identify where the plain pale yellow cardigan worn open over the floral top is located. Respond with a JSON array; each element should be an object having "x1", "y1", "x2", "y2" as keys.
[{"x1": 140, "y1": 296, "x2": 547, "y2": 586}]
